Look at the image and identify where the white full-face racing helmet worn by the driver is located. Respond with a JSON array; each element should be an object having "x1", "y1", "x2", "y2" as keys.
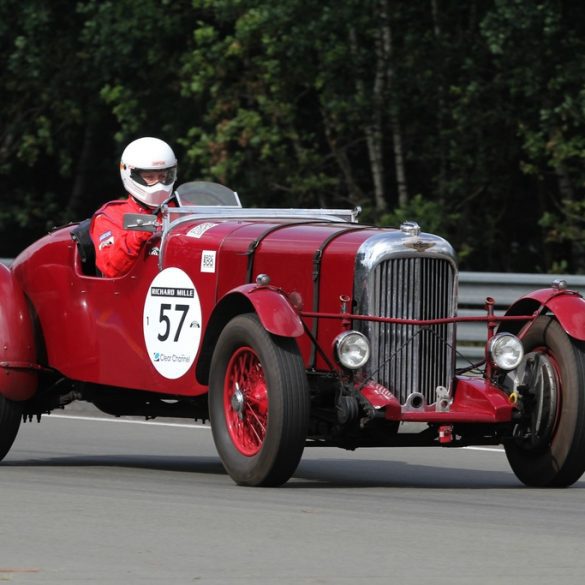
[{"x1": 120, "y1": 137, "x2": 177, "y2": 208}]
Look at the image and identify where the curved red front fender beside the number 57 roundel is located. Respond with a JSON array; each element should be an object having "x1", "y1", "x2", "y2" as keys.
[{"x1": 196, "y1": 284, "x2": 304, "y2": 385}]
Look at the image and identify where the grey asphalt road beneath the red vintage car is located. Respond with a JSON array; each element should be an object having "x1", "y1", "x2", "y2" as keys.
[{"x1": 0, "y1": 415, "x2": 585, "y2": 585}]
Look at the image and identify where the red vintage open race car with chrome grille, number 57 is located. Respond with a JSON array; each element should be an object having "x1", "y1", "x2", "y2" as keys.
[{"x1": 0, "y1": 182, "x2": 585, "y2": 486}]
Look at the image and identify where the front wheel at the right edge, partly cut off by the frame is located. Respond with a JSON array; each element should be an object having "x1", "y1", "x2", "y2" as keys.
[{"x1": 505, "y1": 317, "x2": 585, "y2": 487}]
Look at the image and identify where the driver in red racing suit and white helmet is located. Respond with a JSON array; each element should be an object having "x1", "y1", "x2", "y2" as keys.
[{"x1": 90, "y1": 137, "x2": 177, "y2": 277}]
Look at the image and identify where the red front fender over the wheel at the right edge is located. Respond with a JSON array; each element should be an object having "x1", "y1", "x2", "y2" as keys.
[{"x1": 506, "y1": 288, "x2": 585, "y2": 341}]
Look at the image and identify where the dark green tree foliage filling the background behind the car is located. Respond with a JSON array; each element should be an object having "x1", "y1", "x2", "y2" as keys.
[{"x1": 0, "y1": 0, "x2": 585, "y2": 272}]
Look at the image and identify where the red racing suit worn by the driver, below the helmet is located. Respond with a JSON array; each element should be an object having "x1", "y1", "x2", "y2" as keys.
[{"x1": 89, "y1": 197, "x2": 152, "y2": 277}]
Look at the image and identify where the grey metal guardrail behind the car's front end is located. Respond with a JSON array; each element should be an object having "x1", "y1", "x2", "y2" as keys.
[{"x1": 0, "y1": 258, "x2": 585, "y2": 367}]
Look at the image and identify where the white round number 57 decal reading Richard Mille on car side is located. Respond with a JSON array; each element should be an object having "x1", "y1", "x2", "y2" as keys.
[{"x1": 143, "y1": 268, "x2": 201, "y2": 380}]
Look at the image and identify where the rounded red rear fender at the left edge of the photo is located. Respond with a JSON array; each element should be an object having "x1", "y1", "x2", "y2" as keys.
[{"x1": 0, "y1": 264, "x2": 38, "y2": 401}]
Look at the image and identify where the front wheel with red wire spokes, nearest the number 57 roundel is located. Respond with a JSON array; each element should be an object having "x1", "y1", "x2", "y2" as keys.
[{"x1": 209, "y1": 314, "x2": 309, "y2": 486}]
